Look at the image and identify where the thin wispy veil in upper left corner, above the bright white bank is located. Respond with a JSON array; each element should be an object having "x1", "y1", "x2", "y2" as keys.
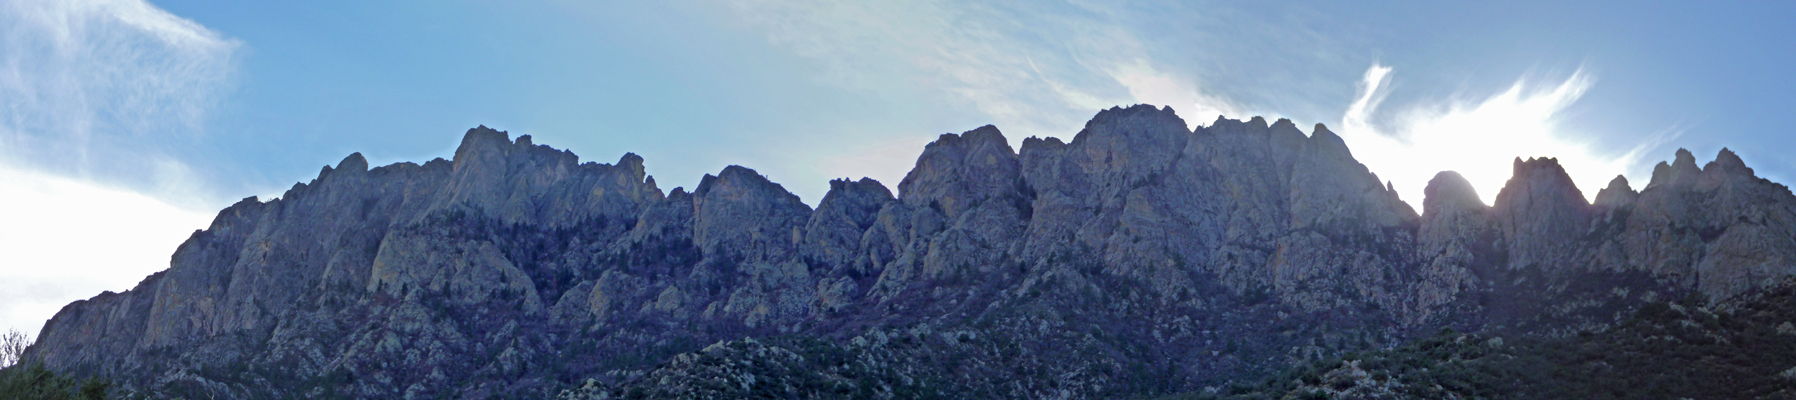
[{"x1": 0, "y1": 0, "x2": 241, "y2": 197}]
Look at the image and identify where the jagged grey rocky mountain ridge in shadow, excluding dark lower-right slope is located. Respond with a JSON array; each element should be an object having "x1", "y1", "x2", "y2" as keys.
[{"x1": 17, "y1": 106, "x2": 1796, "y2": 398}]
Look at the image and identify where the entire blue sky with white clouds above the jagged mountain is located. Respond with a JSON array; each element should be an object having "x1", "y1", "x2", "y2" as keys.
[{"x1": 0, "y1": 0, "x2": 1796, "y2": 337}]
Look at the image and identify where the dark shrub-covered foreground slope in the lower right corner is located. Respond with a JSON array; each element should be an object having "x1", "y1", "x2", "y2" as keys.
[{"x1": 1167, "y1": 289, "x2": 1796, "y2": 398}]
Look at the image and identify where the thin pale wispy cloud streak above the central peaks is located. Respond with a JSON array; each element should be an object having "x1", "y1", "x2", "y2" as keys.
[{"x1": 711, "y1": 0, "x2": 1239, "y2": 140}]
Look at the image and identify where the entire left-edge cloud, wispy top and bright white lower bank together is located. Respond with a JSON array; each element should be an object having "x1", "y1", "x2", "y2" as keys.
[{"x1": 0, "y1": 0, "x2": 241, "y2": 334}]
